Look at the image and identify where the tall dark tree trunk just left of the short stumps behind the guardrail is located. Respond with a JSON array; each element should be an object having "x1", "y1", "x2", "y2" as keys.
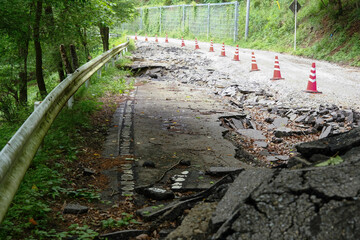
[{"x1": 34, "y1": 0, "x2": 47, "y2": 98}]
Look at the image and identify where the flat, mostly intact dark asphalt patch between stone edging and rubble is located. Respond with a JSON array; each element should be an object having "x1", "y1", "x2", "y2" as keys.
[{"x1": 134, "y1": 81, "x2": 246, "y2": 185}]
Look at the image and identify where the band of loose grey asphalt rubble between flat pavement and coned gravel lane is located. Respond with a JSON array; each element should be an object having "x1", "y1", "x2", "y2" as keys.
[{"x1": 130, "y1": 45, "x2": 360, "y2": 167}]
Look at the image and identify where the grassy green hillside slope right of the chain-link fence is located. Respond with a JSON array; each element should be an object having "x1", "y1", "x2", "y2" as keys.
[{"x1": 239, "y1": 0, "x2": 360, "y2": 66}]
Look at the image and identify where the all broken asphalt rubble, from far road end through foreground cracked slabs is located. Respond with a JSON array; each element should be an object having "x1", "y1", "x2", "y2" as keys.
[{"x1": 109, "y1": 42, "x2": 360, "y2": 240}]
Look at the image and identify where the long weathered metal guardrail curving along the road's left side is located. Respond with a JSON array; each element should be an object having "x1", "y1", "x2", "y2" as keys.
[{"x1": 0, "y1": 41, "x2": 129, "y2": 223}]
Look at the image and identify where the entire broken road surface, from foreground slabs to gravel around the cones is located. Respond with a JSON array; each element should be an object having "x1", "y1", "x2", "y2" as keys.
[{"x1": 100, "y1": 37, "x2": 360, "y2": 239}]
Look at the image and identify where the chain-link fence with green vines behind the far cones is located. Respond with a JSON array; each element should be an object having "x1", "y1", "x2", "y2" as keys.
[{"x1": 121, "y1": 2, "x2": 239, "y2": 41}]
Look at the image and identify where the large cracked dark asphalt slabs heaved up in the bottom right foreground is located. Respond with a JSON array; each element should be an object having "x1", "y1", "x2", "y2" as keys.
[{"x1": 212, "y1": 128, "x2": 360, "y2": 239}]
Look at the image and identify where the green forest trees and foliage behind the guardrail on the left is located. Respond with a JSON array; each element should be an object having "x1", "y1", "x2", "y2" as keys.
[{"x1": 0, "y1": 0, "x2": 136, "y2": 122}]
